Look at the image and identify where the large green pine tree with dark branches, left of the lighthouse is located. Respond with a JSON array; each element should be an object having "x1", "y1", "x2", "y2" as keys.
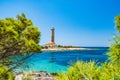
[{"x1": 0, "y1": 14, "x2": 41, "y2": 69}]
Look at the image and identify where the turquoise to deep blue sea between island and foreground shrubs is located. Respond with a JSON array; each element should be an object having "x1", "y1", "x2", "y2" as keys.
[{"x1": 17, "y1": 49, "x2": 107, "y2": 73}]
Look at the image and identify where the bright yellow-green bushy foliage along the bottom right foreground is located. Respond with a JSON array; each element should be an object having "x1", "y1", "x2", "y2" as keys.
[{"x1": 56, "y1": 61, "x2": 120, "y2": 80}]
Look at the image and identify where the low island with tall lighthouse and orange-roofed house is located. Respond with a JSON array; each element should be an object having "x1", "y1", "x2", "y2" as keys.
[{"x1": 42, "y1": 27, "x2": 90, "y2": 52}]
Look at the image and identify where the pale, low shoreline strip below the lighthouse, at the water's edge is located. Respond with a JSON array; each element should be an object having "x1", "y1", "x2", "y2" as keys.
[{"x1": 42, "y1": 48, "x2": 91, "y2": 52}]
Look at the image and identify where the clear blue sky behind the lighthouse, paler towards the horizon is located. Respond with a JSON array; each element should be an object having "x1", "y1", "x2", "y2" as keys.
[{"x1": 0, "y1": 0, "x2": 120, "y2": 47}]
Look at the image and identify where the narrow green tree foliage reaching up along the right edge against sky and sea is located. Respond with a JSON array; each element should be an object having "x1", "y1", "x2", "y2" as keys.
[{"x1": 108, "y1": 15, "x2": 120, "y2": 67}]
